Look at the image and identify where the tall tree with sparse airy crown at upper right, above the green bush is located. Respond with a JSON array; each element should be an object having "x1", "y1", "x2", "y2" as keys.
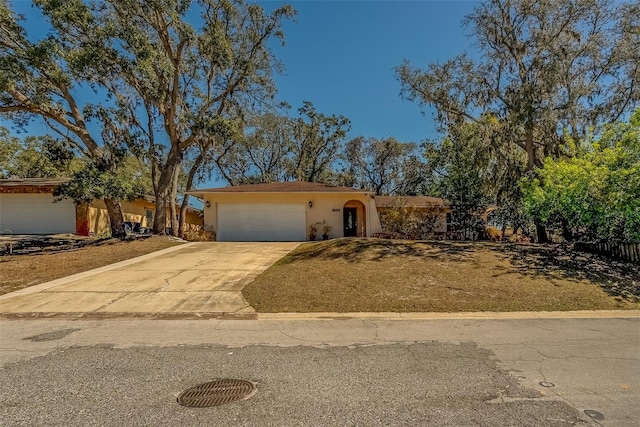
[{"x1": 396, "y1": 0, "x2": 640, "y2": 241}]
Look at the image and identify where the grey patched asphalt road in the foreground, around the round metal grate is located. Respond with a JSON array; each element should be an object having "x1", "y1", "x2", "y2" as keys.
[{"x1": 0, "y1": 318, "x2": 640, "y2": 426}]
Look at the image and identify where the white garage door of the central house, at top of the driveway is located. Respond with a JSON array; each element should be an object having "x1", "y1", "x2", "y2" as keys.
[{"x1": 217, "y1": 203, "x2": 307, "y2": 242}]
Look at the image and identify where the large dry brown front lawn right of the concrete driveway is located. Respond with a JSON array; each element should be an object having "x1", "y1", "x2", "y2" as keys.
[{"x1": 243, "y1": 239, "x2": 640, "y2": 312}]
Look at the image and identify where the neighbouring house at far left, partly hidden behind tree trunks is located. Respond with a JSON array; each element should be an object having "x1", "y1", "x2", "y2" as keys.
[{"x1": 0, "y1": 178, "x2": 202, "y2": 236}]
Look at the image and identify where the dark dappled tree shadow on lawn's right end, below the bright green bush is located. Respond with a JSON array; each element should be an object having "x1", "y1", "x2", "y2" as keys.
[{"x1": 486, "y1": 243, "x2": 640, "y2": 302}]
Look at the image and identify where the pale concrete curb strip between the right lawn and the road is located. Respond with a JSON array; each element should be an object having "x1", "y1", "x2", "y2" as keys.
[{"x1": 258, "y1": 310, "x2": 640, "y2": 321}]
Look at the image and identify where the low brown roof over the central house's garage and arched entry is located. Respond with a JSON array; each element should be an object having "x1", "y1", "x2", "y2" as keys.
[{"x1": 188, "y1": 181, "x2": 370, "y2": 196}]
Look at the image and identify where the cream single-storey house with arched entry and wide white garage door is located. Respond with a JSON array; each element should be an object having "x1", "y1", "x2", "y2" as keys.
[{"x1": 188, "y1": 181, "x2": 381, "y2": 241}]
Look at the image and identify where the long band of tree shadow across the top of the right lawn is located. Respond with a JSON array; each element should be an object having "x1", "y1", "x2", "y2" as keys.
[{"x1": 276, "y1": 238, "x2": 640, "y2": 303}]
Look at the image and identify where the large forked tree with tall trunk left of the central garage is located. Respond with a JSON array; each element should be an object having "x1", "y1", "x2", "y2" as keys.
[{"x1": 97, "y1": 0, "x2": 294, "y2": 232}]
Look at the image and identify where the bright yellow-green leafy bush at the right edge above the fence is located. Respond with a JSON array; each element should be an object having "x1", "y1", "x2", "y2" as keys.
[{"x1": 522, "y1": 109, "x2": 640, "y2": 243}]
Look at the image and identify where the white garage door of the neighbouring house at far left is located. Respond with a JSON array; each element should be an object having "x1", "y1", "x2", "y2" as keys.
[{"x1": 0, "y1": 194, "x2": 76, "y2": 234}]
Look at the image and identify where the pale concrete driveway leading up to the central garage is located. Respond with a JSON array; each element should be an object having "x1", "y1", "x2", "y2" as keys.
[{"x1": 0, "y1": 242, "x2": 298, "y2": 317}]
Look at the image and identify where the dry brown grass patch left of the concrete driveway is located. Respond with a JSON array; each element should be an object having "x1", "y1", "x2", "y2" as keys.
[{"x1": 0, "y1": 236, "x2": 180, "y2": 295}]
